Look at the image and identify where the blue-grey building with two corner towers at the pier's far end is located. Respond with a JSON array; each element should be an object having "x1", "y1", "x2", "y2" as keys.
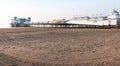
[{"x1": 11, "y1": 17, "x2": 31, "y2": 27}]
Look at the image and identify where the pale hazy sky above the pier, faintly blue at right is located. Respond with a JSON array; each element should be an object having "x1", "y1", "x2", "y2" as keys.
[{"x1": 0, "y1": 0, "x2": 120, "y2": 28}]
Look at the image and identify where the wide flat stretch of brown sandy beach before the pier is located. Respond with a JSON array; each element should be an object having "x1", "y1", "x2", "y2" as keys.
[{"x1": 0, "y1": 28, "x2": 120, "y2": 66}]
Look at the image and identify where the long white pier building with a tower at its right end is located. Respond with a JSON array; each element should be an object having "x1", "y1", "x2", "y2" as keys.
[{"x1": 67, "y1": 9, "x2": 120, "y2": 26}]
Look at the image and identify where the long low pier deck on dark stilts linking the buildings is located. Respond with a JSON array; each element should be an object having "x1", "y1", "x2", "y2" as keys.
[{"x1": 24, "y1": 23, "x2": 118, "y2": 28}]
